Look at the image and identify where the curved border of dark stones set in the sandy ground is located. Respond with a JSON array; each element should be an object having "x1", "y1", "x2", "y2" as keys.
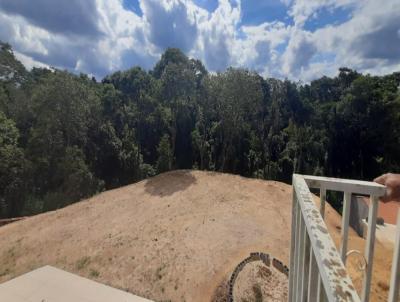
[{"x1": 227, "y1": 252, "x2": 289, "y2": 302}]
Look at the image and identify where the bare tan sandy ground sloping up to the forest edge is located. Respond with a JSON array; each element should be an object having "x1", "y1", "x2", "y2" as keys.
[{"x1": 0, "y1": 171, "x2": 392, "y2": 301}]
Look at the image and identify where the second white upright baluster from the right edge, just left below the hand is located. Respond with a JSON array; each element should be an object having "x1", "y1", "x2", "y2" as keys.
[{"x1": 361, "y1": 196, "x2": 378, "y2": 302}]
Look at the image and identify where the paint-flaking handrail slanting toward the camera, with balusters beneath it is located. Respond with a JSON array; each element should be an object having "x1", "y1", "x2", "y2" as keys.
[{"x1": 289, "y1": 174, "x2": 360, "y2": 302}]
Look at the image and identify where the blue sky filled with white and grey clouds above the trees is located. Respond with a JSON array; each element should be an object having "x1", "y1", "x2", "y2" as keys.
[{"x1": 0, "y1": 0, "x2": 400, "y2": 81}]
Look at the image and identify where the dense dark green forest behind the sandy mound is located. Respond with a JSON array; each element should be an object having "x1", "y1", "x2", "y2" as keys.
[{"x1": 0, "y1": 43, "x2": 400, "y2": 218}]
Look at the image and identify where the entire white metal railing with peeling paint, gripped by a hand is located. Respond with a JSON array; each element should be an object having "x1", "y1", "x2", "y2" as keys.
[{"x1": 289, "y1": 174, "x2": 400, "y2": 302}]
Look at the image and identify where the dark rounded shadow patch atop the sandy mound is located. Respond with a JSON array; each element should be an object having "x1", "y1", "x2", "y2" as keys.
[{"x1": 144, "y1": 170, "x2": 196, "y2": 197}]
